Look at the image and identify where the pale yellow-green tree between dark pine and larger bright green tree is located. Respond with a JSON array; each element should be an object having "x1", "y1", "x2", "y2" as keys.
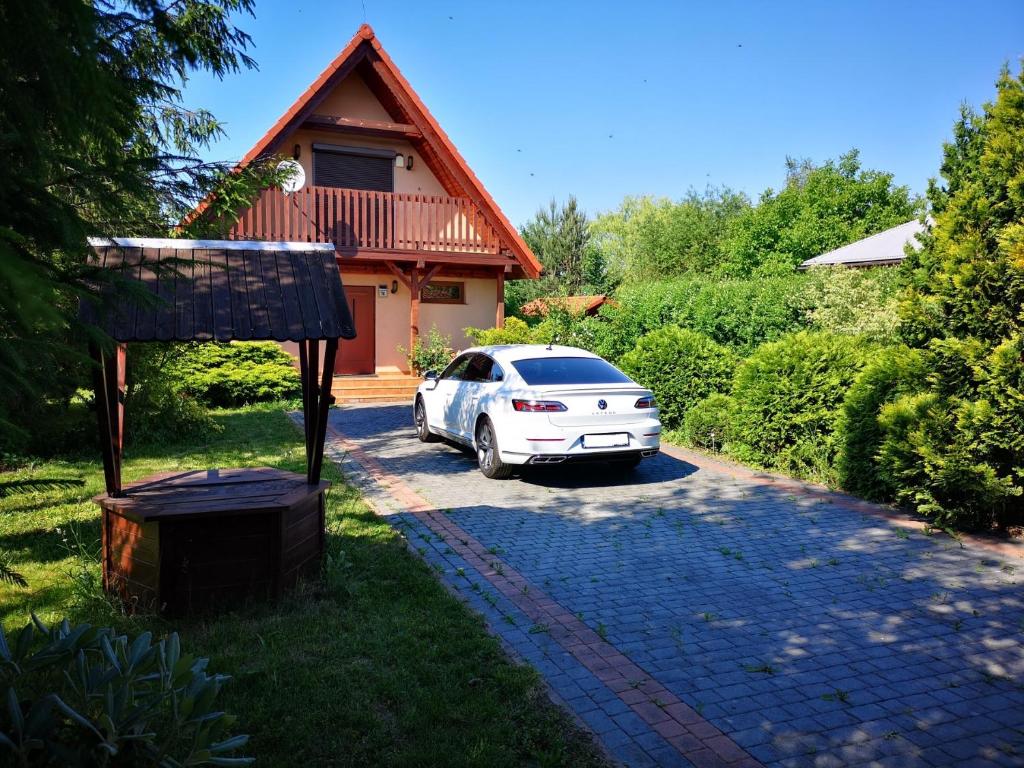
[{"x1": 593, "y1": 186, "x2": 751, "y2": 282}]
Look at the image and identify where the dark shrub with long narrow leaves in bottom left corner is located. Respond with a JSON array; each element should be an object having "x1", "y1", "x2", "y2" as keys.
[{"x1": 0, "y1": 620, "x2": 253, "y2": 768}]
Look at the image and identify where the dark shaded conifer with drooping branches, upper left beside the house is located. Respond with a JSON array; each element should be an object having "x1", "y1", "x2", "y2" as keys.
[{"x1": 0, "y1": 0, "x2": 288, "y2": 451}]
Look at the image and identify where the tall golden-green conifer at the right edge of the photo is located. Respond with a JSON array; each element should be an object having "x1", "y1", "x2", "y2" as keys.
[{"x1": 879, "y1": 68, "x2": 1024, "y2": 528}]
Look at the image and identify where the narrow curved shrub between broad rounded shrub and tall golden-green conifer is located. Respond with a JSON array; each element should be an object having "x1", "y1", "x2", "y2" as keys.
[{"x1": 836, "y1": 346, "x2": 928, "y2": 501}]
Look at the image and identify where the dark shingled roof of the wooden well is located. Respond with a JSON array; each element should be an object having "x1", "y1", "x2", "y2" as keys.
[{"x1": 81, "y1": 238, "x2": 355, "y2": 342}]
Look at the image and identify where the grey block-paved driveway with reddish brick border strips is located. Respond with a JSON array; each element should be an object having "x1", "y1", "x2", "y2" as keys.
[{"x1": 329, "y1": 406, "x2": 1024, "y2": 766}]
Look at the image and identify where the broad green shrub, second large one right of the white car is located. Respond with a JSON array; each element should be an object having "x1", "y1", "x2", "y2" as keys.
[{"x1": 732, "y1": 331, "x2": 863, "y2": 481}]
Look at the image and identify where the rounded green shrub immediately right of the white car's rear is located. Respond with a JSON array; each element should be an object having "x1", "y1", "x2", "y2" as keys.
[{"x1": 620, "y1": 326, "x2": 736, "y2": 429}]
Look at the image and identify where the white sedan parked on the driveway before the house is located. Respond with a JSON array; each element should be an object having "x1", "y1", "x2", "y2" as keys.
[{"x1": 413, "y1": 344, "x2": 662, "y2": 478}]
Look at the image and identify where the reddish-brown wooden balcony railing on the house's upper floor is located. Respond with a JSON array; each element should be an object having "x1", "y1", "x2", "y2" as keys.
[{"x1": 228, "y1": 186, "x2": 501, "y2": 254}]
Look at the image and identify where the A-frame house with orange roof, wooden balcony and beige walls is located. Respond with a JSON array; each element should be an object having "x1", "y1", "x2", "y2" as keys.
[{"x1": 228, "y1": 25, "x2": 541, "y2": 374}]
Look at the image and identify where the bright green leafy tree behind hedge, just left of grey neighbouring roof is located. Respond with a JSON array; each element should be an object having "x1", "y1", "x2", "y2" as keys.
[{"x1": 723, "y1": 150, "x2": 923, "y2": 275}]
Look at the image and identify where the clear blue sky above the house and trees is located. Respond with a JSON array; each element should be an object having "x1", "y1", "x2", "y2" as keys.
[{"x1": 186, "y1": 0, "x2": 1024, "y2": 225}]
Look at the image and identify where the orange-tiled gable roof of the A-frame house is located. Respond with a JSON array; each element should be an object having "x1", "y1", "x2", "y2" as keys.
[{"x1": 229, "y1": 24, "x2": 542, "y2": 278}]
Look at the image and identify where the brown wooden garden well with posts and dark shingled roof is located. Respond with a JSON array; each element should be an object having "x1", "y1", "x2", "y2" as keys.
[{"x1": 82, "y1": 239, "x2": 355, "y2": 613}]
